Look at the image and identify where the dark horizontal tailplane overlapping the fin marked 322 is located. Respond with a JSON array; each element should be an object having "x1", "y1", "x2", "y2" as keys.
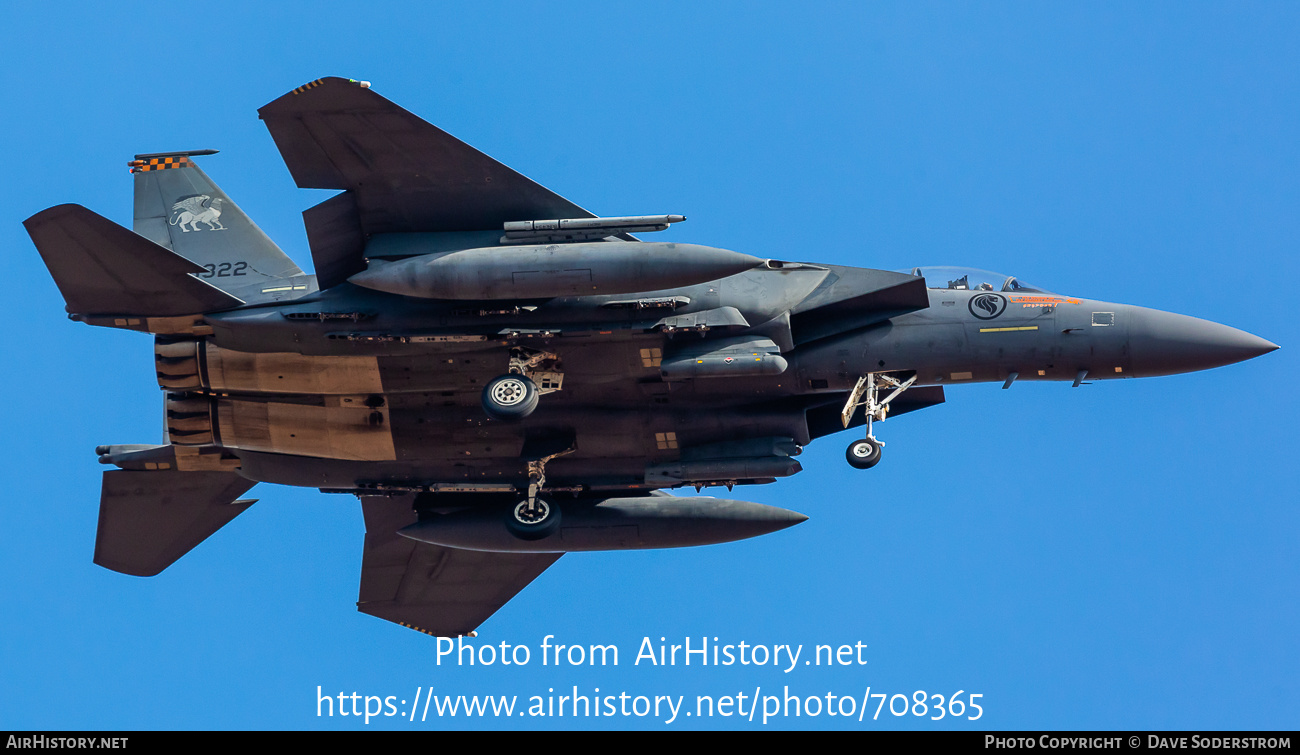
[{"x1": 22, "y1": 204, "x2": 243, "y2": 317}]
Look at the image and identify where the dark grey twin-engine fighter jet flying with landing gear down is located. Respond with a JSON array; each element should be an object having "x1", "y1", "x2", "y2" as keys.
[{"x1": 25, "y1": 78, "x2": 1277, "y2": 635}]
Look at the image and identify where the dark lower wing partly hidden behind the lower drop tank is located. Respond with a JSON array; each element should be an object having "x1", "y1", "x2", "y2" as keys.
[{"x1": 356, "y1": 495, "x2": 562, "y2": 637}]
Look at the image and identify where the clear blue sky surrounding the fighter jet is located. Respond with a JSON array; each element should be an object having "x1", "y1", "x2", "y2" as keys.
[{"x1": 0, "y1": 3, "x2": 1300, "y2": 730}]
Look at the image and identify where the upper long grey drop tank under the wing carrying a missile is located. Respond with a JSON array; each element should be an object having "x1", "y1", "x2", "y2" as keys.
[{"x1": 348, "y1": 242, "x2": 763, "y2": 299}]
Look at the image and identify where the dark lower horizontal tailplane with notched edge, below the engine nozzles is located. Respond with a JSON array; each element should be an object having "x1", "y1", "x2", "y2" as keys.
[{"x1": 95, "y1": 469, "x2": 256, "y2": 577}]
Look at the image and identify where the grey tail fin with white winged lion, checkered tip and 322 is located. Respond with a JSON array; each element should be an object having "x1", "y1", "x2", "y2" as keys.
[{"x1": 130, "y1": 149, "x2": 316, "y2": 304}]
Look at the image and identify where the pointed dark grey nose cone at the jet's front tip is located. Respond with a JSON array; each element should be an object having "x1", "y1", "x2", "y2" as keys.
[{"x1": 1128, "y1": 307, "x2": 1278, "y2": 376}]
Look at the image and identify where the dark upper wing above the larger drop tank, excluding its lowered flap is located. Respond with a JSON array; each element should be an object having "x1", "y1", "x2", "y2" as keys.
[{"x1": 257, "y1": 77, "x2": 594, "y2": 235}]
